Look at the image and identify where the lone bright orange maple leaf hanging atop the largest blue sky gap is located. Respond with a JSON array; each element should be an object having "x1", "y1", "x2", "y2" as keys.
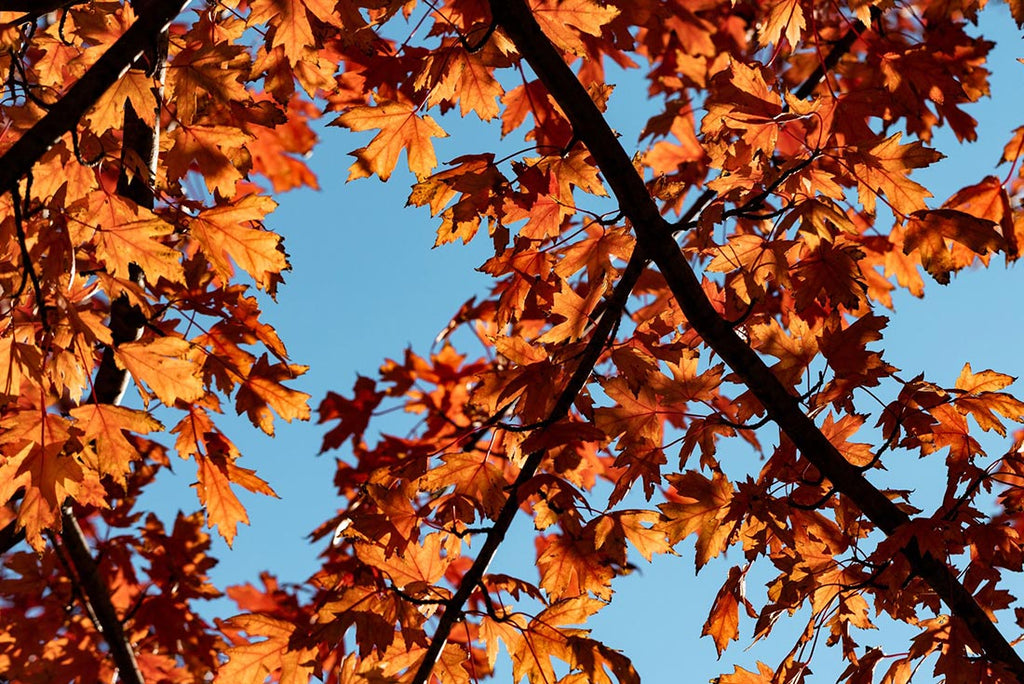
[{"x1": 329, "y1": 99, "x2": 447, "y2": 180}]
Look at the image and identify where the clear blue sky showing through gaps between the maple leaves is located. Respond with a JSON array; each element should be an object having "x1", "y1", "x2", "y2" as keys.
[{"x1": 142, "y1": 4, "x2": 1024, "y2": 682}]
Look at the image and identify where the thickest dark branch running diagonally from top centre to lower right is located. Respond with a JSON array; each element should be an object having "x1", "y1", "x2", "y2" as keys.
[{"x1": 490, "y1": 0, "x2": 1024, "y2": 681}]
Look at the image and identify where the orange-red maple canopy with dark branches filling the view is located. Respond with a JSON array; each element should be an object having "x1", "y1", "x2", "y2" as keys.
[{"x1": 0, "y1": 0, "x2": 1024, "y2": 684}]
